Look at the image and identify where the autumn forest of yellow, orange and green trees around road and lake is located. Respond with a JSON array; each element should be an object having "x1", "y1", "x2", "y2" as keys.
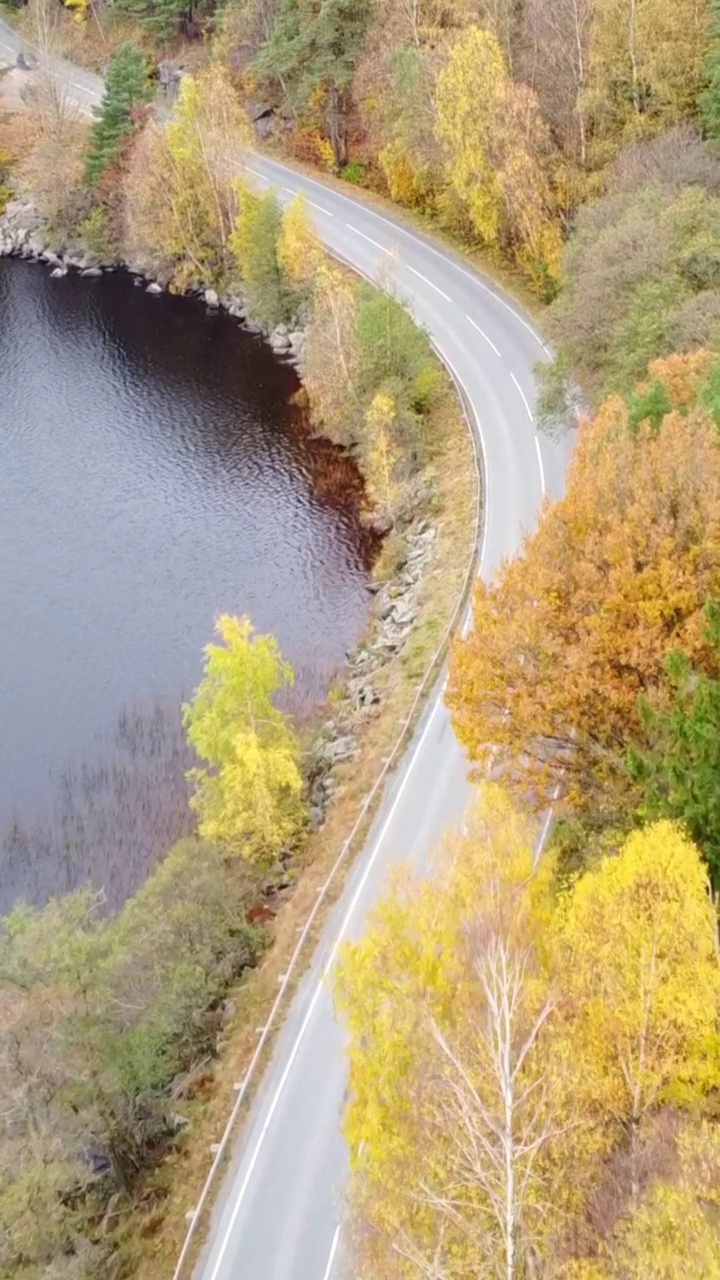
[{"x1": 0, "y1": 0, "x2": 720, "y2": 1280}]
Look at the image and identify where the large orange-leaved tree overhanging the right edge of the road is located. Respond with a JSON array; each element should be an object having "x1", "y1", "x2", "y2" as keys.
[{"x1": 447, "y1": 356, "x2": 720, "y2": 813}]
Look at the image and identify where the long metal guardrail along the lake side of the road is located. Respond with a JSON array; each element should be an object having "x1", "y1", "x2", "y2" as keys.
[{"x1": 173, "y1": 348, "x2": 484, "y2": 1280}]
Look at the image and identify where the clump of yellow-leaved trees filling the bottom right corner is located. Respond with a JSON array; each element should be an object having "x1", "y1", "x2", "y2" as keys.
[{"x1": 337, "y1": 786, "x2": 720, "y2": 1280}]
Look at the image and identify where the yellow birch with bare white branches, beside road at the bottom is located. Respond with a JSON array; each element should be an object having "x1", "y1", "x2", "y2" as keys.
[{"x1": 338, "y1": 787, "x2": 562, "y2": 1280}]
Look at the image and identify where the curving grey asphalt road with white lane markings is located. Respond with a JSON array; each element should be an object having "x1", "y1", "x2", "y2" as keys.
[{"x1": 0, "y1": 23, "x2": 569, "y2": 1280}]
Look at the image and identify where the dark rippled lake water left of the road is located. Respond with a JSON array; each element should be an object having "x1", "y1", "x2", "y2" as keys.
[{"x1": 0, "y1": 260, "x2": 368, "y2": 909}]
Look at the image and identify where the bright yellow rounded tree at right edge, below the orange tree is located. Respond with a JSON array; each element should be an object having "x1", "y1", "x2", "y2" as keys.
[{"x1": 556, "y1": 822, "x2": 720, "y2": 1198}]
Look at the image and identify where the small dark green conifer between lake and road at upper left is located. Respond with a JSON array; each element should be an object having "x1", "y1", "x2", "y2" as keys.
[{"x1": 85, "y1": 44, "x2": 152, "y2": 187}]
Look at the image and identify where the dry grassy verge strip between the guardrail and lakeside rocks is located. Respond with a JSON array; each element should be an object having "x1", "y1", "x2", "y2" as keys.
[{"x1": 114, "y1": 363, "x2": 478, "y2": 1280}]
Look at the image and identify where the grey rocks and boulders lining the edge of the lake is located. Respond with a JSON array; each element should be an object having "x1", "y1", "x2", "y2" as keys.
[{"x1": 0, "y1": 192, "x2": 437, "y2": 829}]
